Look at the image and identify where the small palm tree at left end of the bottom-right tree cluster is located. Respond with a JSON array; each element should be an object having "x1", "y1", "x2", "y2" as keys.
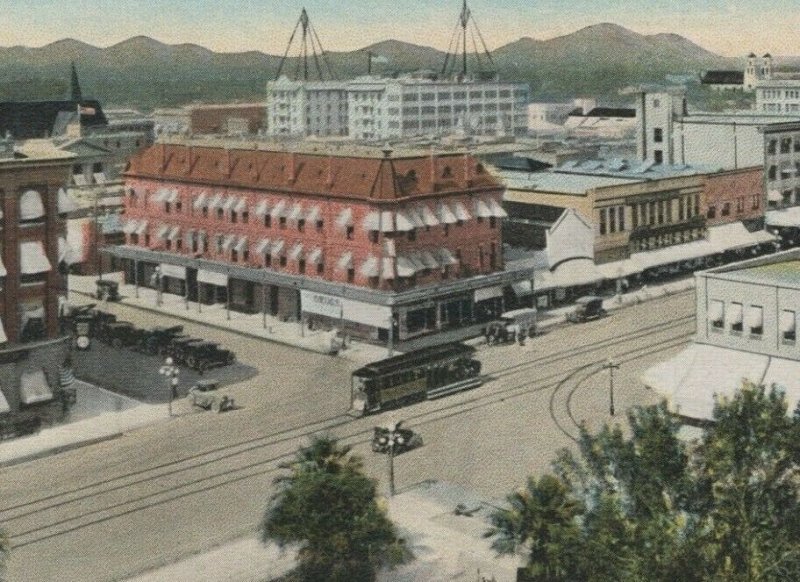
[{"x1": 484, "y1": 475, "x2": 583, "y2": 580}]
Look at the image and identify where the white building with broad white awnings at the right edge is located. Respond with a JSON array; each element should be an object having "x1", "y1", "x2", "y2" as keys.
[{"x1": 642, "y1": 250, "x2": 800, "y2": 420}]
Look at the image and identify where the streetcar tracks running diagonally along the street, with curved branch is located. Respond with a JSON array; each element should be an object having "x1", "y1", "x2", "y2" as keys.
[{"x1": 0, "y1": 304, "x2": 693, "y2": 548}]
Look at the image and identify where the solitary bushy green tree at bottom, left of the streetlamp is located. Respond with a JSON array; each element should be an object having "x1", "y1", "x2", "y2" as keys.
[{"x1": 260, "y1": 437, "x2": 409, "y2": 582}]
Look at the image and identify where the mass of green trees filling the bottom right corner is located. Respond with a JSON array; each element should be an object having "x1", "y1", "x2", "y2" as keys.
[{"x1": 487, "y1": 385, "x2": 800, "y2": 582}]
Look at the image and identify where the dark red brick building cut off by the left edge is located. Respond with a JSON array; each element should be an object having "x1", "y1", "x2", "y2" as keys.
[{"x1": 0, "y1": 139, "x2": 74, "y2": 426}]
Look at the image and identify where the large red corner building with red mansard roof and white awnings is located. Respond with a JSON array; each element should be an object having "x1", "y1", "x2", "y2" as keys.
[{"x1": 111, "y1": 142, "x2": 530, "y2": 340}]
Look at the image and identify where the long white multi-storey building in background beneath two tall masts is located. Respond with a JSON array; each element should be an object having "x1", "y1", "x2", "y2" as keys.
[{"x1": 267, "y1": 77, "x2": 529, "y2": 140}]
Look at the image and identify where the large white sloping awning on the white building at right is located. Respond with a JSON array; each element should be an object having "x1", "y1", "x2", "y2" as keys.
[{"x1": 642, "y1": 344, "x2": 772, "y2": 419}]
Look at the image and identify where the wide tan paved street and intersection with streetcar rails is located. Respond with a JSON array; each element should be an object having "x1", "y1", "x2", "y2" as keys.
[{"x1": 0, "y1": 292, "x2": 694, "y2": 581}]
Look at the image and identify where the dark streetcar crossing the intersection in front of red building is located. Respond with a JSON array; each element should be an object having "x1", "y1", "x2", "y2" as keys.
[{"x1": 350, "y1": 343, "x2": 483, "y2": 416}]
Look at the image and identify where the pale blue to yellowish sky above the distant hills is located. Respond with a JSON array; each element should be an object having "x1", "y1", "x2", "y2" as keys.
[{"x1": 0, "y1": 0, "x2": 800, "y2": 56}]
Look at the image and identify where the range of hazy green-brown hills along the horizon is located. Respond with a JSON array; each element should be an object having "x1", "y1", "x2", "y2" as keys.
[{"x1": 0, "y1": 23, "x2": 743, "y2": 109}]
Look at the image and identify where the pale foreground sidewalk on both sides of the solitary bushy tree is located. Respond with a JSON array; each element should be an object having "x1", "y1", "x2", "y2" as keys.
[{"x1": 128, "y1": 482, "x2": 519, "y2": 582}]
